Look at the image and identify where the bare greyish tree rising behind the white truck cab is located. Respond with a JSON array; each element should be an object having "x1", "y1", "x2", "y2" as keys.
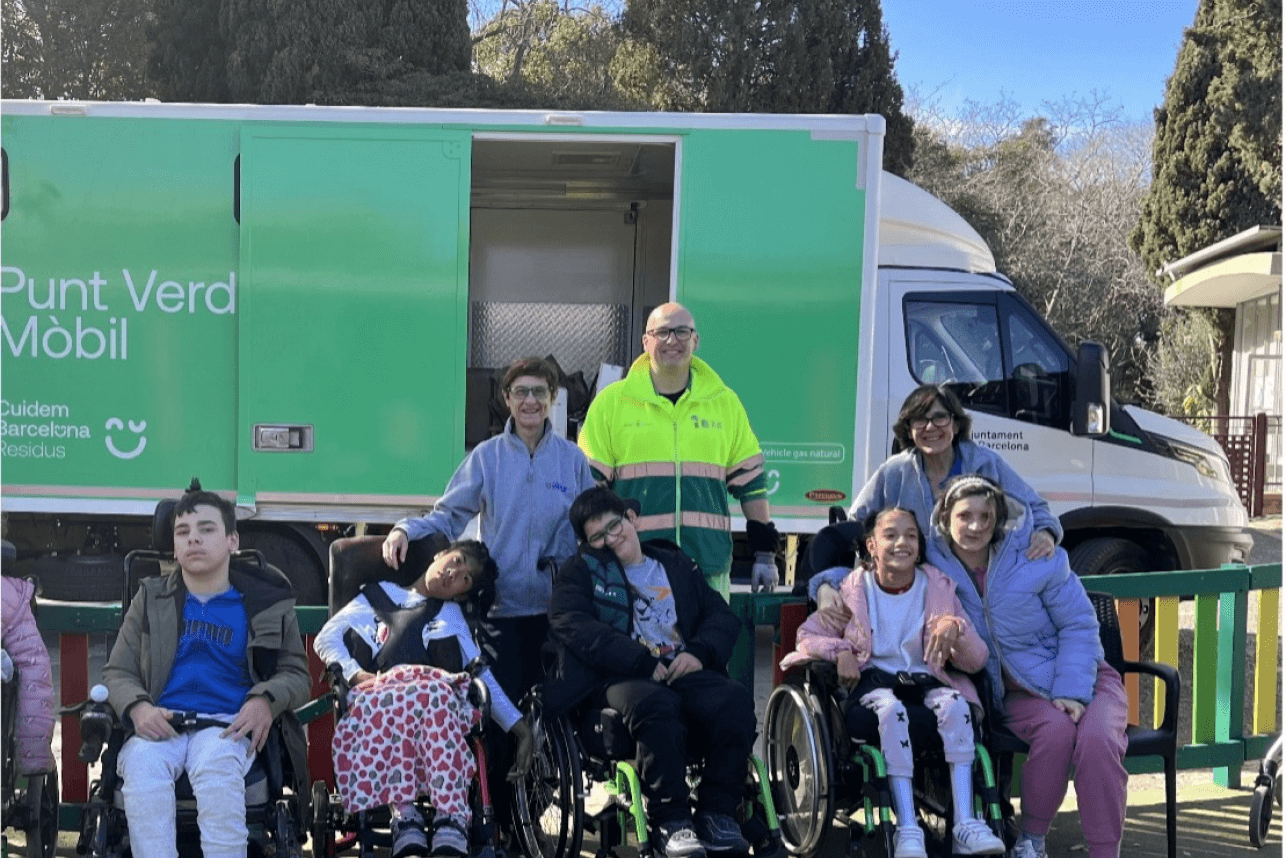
[{"x1": 909, "y1": 93, "x2": 1161, "y2": 400}]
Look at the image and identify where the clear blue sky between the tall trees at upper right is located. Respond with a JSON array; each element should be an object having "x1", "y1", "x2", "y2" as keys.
[{"x1": 881, "y1": 0, "x2": 1199, "y2": 121}]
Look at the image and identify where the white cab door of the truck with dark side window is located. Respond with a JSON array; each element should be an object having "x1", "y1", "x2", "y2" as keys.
[{"x1": 889, "y1": 291, "x2": 1094, "y2": 515}]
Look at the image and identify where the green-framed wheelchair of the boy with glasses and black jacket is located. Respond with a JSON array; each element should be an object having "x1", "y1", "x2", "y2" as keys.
[{"x1": 514, "y1": 688, "x2": 782, "y2": 858}]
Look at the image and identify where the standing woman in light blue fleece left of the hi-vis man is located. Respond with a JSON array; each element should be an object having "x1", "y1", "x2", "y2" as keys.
[{"x1": 383, "y1": 358, "x2": 594, "y2": 701}]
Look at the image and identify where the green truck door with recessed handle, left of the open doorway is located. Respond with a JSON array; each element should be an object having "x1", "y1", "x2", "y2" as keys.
[{"x1": 238, "y1": 123, "x2": 469, "y2": 507}]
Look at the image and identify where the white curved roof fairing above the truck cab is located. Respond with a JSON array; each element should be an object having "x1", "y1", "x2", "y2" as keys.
[{"x1": 880, "y1": 171, "x2": 995, "y2": 274}]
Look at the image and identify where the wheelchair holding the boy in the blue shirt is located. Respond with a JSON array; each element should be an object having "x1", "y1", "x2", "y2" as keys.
[{"x1": 64, "y1": 499, "x2": 309, "y2": 858}]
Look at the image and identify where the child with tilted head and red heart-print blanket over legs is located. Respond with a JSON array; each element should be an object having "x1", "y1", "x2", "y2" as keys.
[{"x1": 314, "y1": 540, "x2": 531, "y2": 858}]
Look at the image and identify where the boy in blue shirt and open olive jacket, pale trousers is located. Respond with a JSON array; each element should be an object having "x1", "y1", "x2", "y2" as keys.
[{"x1": 103, "y1": 482, "x2": 310, "y2": 858}]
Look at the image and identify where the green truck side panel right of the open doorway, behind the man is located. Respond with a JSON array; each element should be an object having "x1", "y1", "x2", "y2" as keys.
[{"x1": 676, "y1": 130, "x2": 878, "y2": 530}]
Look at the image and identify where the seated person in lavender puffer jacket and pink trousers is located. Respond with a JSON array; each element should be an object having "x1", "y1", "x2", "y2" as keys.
[{"x1": 927, "y1": 475, "x2": 1128, "y2": 858}]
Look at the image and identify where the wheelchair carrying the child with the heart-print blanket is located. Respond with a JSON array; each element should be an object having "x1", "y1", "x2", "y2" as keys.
[{"x1": 310, "y1": 535, "x2": 498, "y2": 858}]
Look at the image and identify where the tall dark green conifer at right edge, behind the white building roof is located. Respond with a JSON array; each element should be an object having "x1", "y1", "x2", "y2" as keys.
[{"x1": 1129, "y1": 0, "x2": 1282, "y2": 414}]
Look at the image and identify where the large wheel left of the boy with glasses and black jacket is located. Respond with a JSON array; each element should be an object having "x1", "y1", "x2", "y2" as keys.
[{"x1": 513, "y1": 718, "x2": 585, "y2": 858}]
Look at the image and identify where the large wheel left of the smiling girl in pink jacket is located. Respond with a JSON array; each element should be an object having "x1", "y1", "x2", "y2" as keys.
[{"x1": 764, "y1": 677, "x2": 835, "y2": 855}]
